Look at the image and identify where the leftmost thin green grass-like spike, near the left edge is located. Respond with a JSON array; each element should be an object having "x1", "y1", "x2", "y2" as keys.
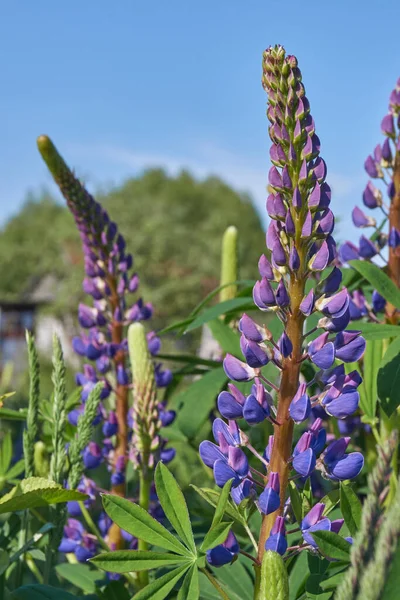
[{"x1": 23, "y1": 331, "x2": 40, "y2": 477}]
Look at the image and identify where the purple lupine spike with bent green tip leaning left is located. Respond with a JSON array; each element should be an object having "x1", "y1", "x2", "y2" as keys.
[{"x1": 38, "y1": 136, "x2": 175, "y2": 548}]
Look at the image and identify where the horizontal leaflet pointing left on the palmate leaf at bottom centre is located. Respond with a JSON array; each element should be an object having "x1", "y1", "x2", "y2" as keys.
[{"x1": 90, "y1": 550, "x2": 190, "y2": 573}]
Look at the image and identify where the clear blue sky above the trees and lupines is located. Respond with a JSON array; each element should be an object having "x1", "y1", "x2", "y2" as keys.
[{"x1": 0, "y1": 0, "x2": 400, "y2": 237}]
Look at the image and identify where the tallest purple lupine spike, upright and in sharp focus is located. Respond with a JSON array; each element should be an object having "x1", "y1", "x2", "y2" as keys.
[{"x1": 200, "y1": 46, "x2": 365, "y2": 598}]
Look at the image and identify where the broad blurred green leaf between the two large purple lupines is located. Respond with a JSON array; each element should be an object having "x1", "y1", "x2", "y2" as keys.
[{"x1": 174, "y1": 367, "x2": 227, "y2": 439}]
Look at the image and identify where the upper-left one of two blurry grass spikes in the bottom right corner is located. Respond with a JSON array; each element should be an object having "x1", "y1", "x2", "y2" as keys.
[{"x1": 335, "y1": 431, "x2": 398, "y2": 600}]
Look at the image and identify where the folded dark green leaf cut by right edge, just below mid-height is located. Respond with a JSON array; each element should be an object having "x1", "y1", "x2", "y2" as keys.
[{"x1": 377, "y1": 338, "x2": 400, "y2": 417}]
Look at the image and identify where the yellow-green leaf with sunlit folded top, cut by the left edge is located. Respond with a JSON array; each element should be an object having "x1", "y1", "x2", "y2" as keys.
[{"x1": 0, "y1": 477, "x2": 87, "y2": 514}]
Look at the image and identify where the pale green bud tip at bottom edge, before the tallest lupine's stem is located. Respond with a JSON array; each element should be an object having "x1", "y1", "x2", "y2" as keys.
[{"x1": 256, "y1": 550, "x2": 289, "y2": 600}]
